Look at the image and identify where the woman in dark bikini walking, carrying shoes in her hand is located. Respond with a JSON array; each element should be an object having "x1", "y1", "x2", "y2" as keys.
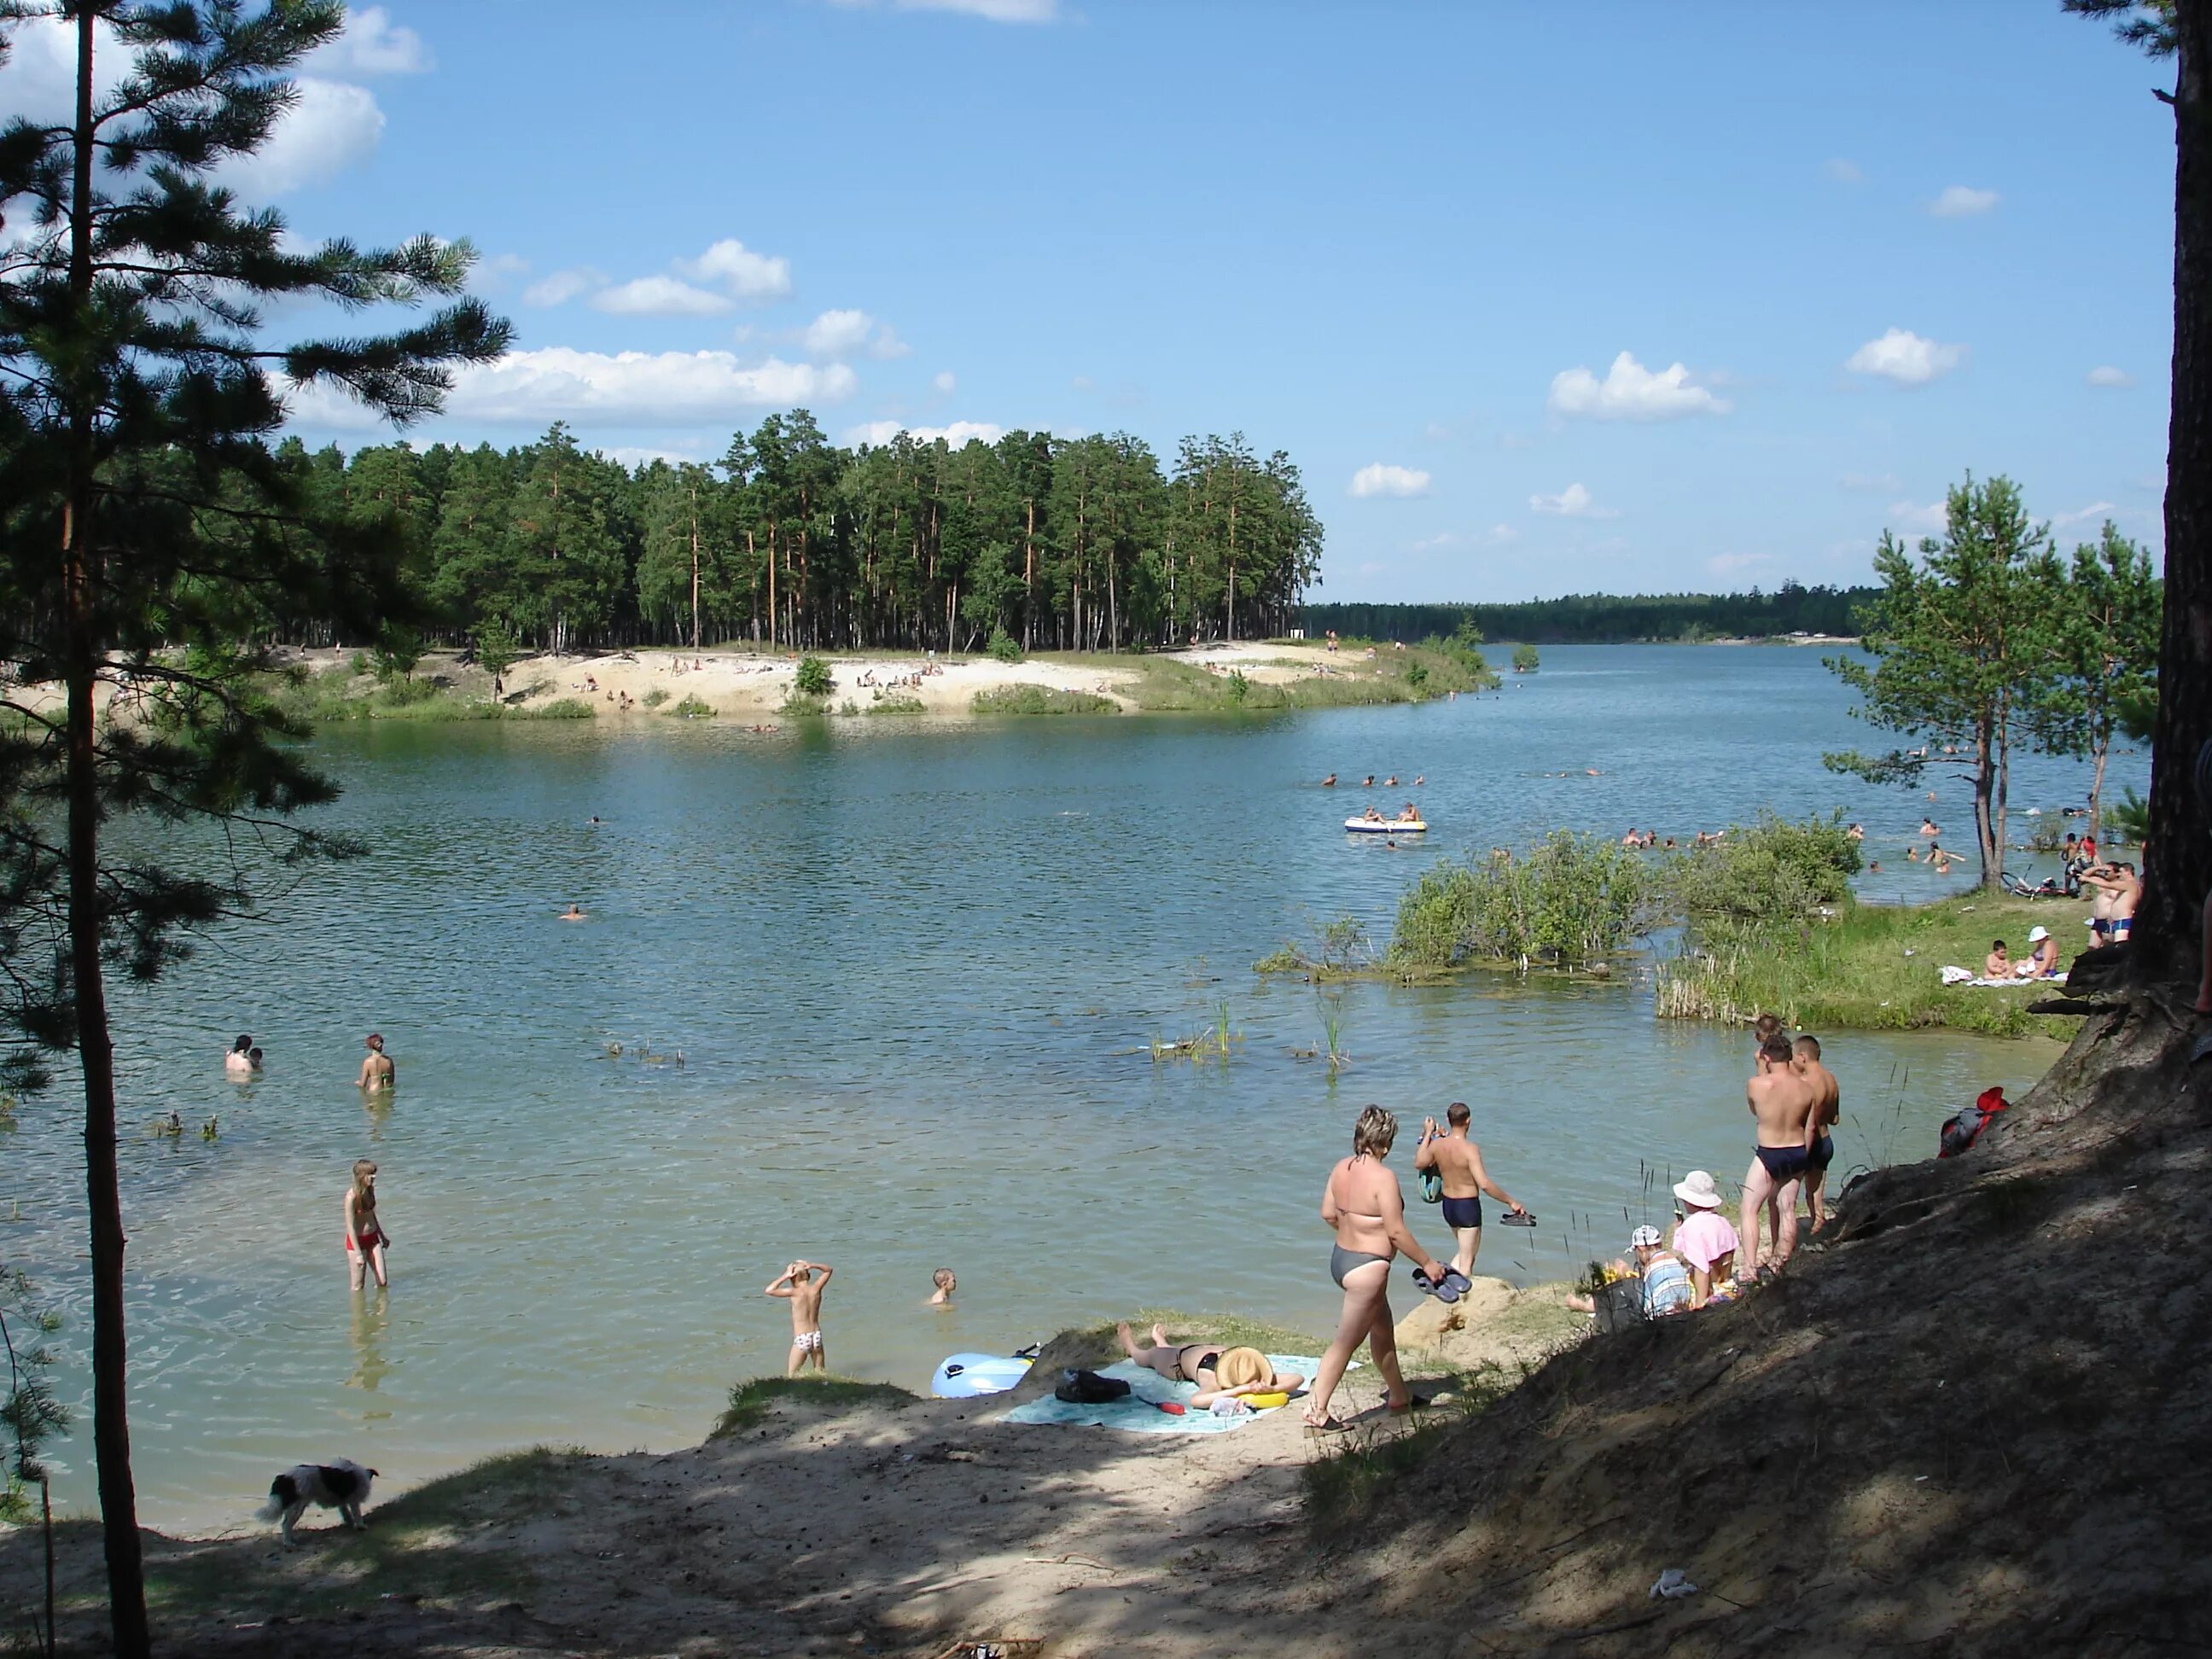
[{"x1": 1305, "y1": 1106, "x2": 1445, "y2": 1429}]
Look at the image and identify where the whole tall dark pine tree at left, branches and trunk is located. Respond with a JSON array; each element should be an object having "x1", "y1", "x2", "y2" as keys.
[{"x1": 0, "y1": 0, "x2": 507, "y2": 1659}]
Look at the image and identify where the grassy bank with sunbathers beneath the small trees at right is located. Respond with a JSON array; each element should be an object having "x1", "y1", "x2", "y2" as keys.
[{"x1": 1656, "y1": 892, "x2": 2088, "y2": 1038}]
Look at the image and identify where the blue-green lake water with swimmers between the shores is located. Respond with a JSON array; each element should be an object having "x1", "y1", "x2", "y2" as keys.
[{"x1": 0, "y1": 646, "x2": 2144, "y2": 1526}]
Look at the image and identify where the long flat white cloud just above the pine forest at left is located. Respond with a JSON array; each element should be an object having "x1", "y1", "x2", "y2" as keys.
[{"x1": 445, "y1": 345, "x2": 859, "y2": 427}]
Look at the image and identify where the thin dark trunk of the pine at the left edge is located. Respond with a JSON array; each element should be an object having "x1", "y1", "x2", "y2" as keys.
[{"x1": 62, "y1": 7, "x2": 153, "y2": 1659}]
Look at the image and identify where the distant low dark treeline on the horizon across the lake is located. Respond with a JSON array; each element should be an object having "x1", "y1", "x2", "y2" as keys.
[{"x1": 1299, "y1": 582, "x2": 1880, "y2": 646}]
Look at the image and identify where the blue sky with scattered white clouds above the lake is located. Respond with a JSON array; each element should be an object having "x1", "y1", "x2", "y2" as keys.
[{"x1": 0, "y1": 0, "x2": 2172, "y2": 599}]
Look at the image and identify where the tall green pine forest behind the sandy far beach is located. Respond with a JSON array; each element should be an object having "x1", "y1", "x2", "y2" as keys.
[{"x1": 270, "y1": 410, "x2": 1323, "y2": 650}]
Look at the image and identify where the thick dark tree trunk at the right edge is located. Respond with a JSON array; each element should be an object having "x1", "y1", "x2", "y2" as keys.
[{"x1": 2133, "y1": 0, "x2": 2212, "y2": 978}]
